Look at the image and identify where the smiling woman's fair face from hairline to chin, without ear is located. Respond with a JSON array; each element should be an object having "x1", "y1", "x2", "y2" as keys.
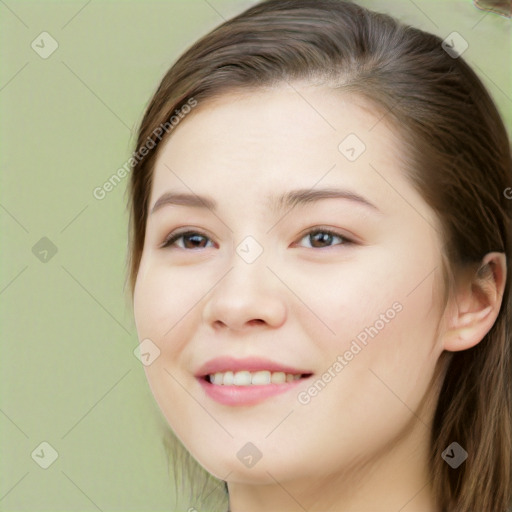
[{"x1": 134, "y1": 85, "x2": 448, "y2": 483}]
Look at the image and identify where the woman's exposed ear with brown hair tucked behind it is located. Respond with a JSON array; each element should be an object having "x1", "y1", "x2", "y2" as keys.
[{"x1": 443, "y1": 252, "x2": 507, "y2": 352}]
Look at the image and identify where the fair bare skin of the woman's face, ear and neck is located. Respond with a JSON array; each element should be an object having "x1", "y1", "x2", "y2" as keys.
[{"x1": 134, "y1": 84, "x2": 505, "y2": 512}]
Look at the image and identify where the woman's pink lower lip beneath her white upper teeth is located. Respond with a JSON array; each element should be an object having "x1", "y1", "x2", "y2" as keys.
[{"x1": 198, "y1": 377, "x2": 309, "y2": 405}]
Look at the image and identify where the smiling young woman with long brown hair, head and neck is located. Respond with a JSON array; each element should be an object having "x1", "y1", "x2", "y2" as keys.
[{"x1": 126, "y1": 0, "x2": 512, "y2": 512}]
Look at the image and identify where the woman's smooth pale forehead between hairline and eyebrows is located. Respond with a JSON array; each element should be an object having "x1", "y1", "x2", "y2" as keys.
[{"x1": 150, "y1": 84, "x2": 403, "y2": 213}]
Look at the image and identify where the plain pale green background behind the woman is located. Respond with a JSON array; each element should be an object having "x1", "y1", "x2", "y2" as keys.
[{"x1": 0, "y1": 0, "x2": 512, "y2": 512}]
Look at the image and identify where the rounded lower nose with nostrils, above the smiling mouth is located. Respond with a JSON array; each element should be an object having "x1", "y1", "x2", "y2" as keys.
[{"x1": 203, "y1": 260, "x2": 287, "y2": 332}]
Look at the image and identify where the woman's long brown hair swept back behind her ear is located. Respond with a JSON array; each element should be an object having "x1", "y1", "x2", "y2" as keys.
[{"x1": 125, "y1": 0, "x2": 512, "y2": 512}]
